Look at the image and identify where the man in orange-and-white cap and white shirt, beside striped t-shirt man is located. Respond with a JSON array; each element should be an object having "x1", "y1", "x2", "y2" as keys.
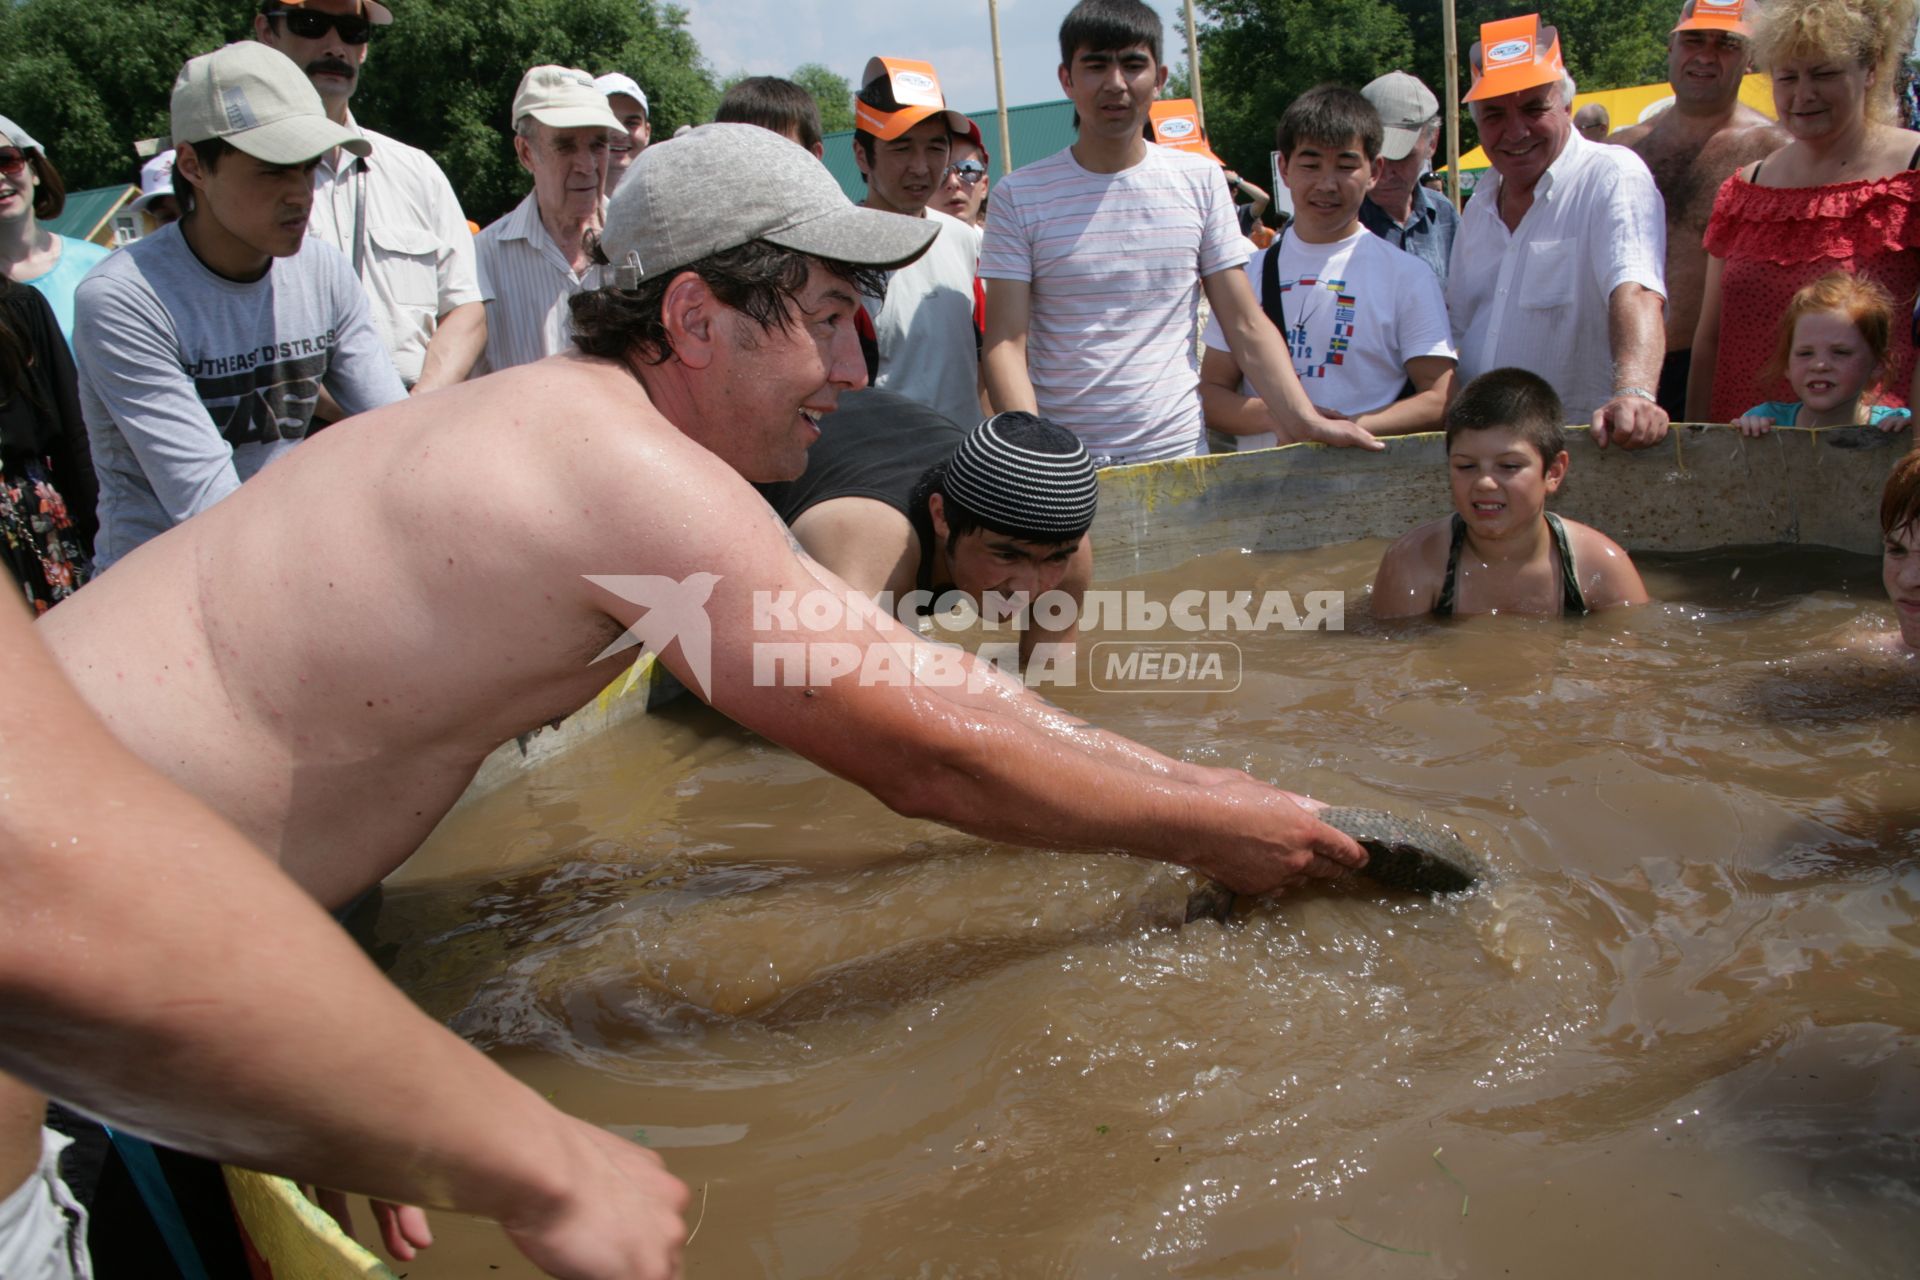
[{"x1": 852, "y1": 58, "x2": 983, "y2": 426}]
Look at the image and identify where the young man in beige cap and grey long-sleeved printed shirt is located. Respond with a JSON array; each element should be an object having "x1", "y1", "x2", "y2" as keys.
[{"x1": 73, "y1": 44, "x2": 407, "y2": 568}]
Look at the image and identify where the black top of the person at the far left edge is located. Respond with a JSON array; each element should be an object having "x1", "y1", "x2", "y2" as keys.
[{"x1": 0, "y1": 276, "x2": 100, "y2": 547}]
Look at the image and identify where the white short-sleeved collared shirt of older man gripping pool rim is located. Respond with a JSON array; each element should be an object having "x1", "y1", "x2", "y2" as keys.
[{"x1": 1446, "y1": 132, "x2": 1667, "y2": 422}]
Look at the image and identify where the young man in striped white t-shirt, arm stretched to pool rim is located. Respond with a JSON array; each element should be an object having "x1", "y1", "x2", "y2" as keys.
[{"x1": 979, "y1": 0, "x2": 1380, "y2": 462}]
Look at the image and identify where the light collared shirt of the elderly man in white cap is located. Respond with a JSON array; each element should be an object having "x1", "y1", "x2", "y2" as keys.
[{"x1": 474, "y1": 192, "x2": 601, "y2": 372}]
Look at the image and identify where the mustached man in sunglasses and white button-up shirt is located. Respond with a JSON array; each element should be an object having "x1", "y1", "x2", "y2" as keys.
[{"x1": 253, "y1": 0, "x2": 486, "y2": 391}]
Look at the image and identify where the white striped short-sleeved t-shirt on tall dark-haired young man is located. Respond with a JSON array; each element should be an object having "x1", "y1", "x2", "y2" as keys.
[{"x1": 979, "y1": 146, "x2": 1252, "y2": 462}]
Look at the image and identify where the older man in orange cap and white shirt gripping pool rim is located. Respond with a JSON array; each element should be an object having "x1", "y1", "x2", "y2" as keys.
[{"x1": 1446, "y1": 13, "x2": 1667, "y2": 449}]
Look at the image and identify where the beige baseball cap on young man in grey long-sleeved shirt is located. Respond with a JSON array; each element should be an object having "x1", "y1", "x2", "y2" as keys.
[{"x1": 171, "y1": 40, "x2": 372, "y2": 165}]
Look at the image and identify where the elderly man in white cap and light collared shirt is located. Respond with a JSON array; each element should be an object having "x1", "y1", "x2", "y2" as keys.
[{"x1": 474, "y1": 65, "x2": 620, "y2": 372}]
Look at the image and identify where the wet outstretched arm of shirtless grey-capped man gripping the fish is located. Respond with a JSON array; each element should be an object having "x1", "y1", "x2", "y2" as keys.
[{"x1": 589, "y1": 485, "x2": 1365, "y2": 892}]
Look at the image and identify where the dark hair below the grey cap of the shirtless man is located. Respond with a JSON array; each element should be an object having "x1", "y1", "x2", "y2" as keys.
[{"x1": 566, "y1": 240, "x2": 885, "y2": 365}]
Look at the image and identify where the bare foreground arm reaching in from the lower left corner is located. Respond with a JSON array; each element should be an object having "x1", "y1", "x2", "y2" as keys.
[{"x1": 0, "y1": 608, "x2": 685, "y2": 1280}]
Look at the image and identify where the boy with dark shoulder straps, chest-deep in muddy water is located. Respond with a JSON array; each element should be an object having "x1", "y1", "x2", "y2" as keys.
[{"x1": 1373, "y1": 368, "x2": 1647, "y2": 618}]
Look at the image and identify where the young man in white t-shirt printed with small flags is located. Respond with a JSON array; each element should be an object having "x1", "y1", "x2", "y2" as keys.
[{"x1": 1200, "y1": 84, "x2": 1455, "y2": 449}]
